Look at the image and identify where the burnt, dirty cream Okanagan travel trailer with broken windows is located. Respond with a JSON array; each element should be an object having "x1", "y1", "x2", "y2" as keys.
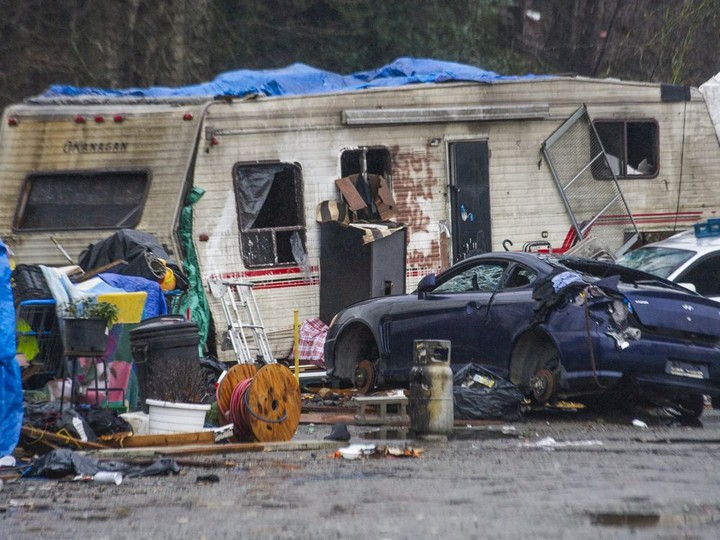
[{"x1": 0, "y1": 61, "x2": 720, "y2": 360}]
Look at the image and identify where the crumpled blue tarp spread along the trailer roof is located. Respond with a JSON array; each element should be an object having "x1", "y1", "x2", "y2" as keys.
[{"x1": 41, "y1": 58, "x2": 544, "y2": 98}]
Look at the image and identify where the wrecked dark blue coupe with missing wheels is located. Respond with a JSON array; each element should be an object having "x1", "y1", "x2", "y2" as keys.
[{"x1": 325, "y1": 252, "x2": 720, "y2": 416}]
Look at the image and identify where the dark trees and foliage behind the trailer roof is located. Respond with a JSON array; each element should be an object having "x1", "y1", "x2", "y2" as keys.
[{"x1": 0, "y1": 0, "x2": 720, "y2": 110}]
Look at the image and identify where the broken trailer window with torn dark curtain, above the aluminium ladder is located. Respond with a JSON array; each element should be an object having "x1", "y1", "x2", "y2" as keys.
[{"x1": 233, "y1": 163, "x2": 305, "y2": 268}]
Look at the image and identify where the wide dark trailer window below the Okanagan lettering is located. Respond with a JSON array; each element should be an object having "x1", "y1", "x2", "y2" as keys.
[{"x1": 13, "y1": 171, "x2": 150, "y2": 231}]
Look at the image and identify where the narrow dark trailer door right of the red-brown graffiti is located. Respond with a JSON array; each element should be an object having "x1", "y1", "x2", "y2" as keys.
[{"x1": 448, "y1": 140, "x2": 492, "y2": 263}]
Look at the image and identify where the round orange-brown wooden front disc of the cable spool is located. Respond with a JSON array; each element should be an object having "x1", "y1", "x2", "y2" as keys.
[{"x1": 245, "y1": 364, "x2": 302, "y2": 442}]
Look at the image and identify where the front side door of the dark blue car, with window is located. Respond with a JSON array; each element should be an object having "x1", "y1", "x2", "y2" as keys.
[{"x1": 383, "y1": 259, "x2": 508, "y2": 375}]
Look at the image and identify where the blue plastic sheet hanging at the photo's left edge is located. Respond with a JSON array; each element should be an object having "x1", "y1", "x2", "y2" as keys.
[{"x1": 0, "y1": 241, "x2": 23, "y2": 456}]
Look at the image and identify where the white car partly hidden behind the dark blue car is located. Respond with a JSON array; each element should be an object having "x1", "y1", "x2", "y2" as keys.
[{"x1": 617, "y1": 227, "x2": 720, "y2": 302}]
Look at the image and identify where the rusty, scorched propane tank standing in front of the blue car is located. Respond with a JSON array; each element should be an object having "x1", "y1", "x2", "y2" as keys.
[{"x1": 408, "y1": 340, "x2": 455, "y2": 435}]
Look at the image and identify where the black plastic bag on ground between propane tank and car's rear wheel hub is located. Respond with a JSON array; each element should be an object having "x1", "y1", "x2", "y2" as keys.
[{"x1": 453, "y1": 364, "x2": 524, "y2": 420}]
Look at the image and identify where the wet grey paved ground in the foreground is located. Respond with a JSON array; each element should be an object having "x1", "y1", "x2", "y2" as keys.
[{"x1": 0, "y1": 410, "x2": 720, "y2": 540}]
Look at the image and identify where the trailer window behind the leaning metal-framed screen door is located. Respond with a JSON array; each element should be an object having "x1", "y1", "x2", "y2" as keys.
[{"x1": 594, "y1": 120, "x2": 659, "y2": 178}]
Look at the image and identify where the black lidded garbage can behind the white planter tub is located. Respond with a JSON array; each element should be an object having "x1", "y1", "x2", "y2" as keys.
[{"x1": 130, "y1": 315, "x2": 201, "y2": 412}]
